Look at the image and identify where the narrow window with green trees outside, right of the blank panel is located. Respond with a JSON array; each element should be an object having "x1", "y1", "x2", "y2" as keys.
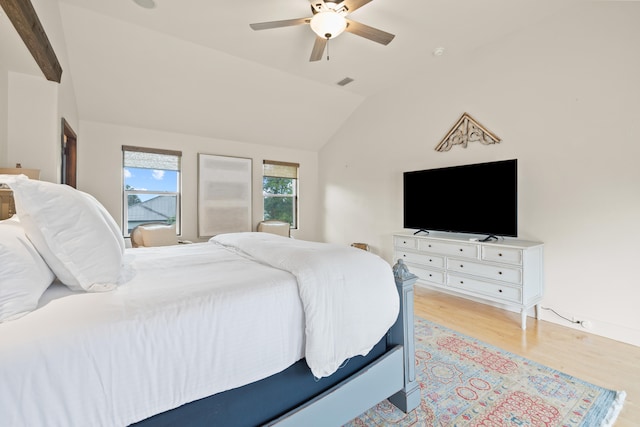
[{"x1": 262, "y1": 160, "x2": 300, "y2": 228}]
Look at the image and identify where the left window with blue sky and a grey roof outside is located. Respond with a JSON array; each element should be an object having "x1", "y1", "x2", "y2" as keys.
[{"x1": 122, "y1": 145, "x2": 182, "y2": 236}]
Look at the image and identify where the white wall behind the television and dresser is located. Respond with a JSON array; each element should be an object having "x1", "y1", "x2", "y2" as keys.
[{"x1": 319, "y1": 2, "x2": 640, "y2": 345}]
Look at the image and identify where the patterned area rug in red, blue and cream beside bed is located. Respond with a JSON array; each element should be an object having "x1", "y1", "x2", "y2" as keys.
[{"x1": 346, "y1": 317, "x2": 625, "y2": 427}]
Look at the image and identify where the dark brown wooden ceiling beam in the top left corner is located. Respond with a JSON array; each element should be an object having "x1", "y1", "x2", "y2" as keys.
[{"x1": 0, "y1": 0, "x2": 62, "y2": 83}]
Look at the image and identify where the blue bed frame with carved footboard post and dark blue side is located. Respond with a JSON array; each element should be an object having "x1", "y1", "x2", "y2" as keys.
[{"x1": 135, "y1": 277, "x2": 420, "y2": 427}]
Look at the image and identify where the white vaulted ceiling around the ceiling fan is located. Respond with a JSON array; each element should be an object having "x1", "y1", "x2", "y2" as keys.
[{"x1": 0, "y1": 0, "x2": 576, "y2": 150}]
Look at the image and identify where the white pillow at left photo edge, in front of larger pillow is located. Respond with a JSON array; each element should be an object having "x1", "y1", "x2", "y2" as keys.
[{"x1": 0, "y1": 215, "x2": 55, "y2": 323}]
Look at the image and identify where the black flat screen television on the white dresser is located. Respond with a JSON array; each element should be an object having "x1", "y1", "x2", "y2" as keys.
[{"x1": 403, "y1": 159, "x2": 518, "y2": 237}]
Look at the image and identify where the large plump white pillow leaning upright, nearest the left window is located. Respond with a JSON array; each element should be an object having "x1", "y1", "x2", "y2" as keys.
[{"x1": 5, "y1": 175, "x2": 124, "y2": 292}]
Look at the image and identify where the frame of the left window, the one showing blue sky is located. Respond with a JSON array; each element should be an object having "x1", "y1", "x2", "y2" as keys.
[{"x1": 121, "y1": 145, "x2": 182, "y2": 237}]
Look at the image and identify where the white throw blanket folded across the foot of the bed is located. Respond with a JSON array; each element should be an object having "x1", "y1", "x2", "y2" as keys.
[{"x1": 210, "y1": 232, "x2": 399, "y2": 378}]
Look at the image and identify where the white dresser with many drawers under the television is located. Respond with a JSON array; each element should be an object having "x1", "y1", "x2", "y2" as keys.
[{"x1": 393, "y1": 232, "x2": 544, "y2": 329}]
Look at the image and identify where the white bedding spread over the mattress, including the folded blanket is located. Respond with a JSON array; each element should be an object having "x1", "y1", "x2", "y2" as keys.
[{"x1": 0, "y1": 233, "x2": 398, "y2": 427}]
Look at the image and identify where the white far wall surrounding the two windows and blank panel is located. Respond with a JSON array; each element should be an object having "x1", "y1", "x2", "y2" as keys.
[{"x1": 78, "y1": 121, "x2": 319, "y2": 241}]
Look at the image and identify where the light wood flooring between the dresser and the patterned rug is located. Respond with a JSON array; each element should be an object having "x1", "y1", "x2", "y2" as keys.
[{"x1": 414, "y1": 286, "x2": 640, "y2": 427}]
